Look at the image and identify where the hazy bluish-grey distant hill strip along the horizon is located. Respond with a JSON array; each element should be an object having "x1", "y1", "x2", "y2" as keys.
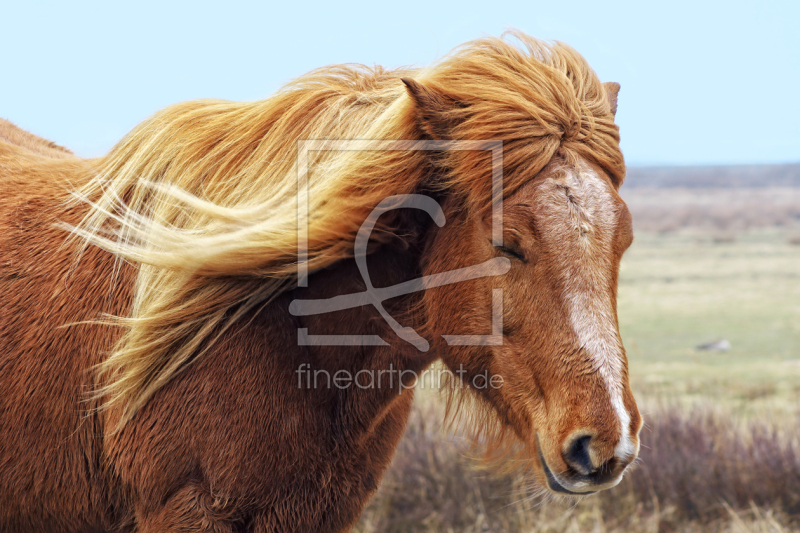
[{"x1": 624, "y1": 163, "x2": 800, "y2": 189}]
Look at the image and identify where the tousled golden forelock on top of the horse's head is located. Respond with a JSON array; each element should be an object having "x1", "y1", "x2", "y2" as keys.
[{"x1": 411, "y1": 32, "x2": 625, "y2": 212}]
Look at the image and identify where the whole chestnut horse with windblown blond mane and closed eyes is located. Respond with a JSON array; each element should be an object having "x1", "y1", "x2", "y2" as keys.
[{"x1": 0, "y1": 32, "x2": 642, "y2": 533}]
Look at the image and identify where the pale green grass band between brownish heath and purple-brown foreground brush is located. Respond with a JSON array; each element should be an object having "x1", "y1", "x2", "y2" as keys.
[{"x1": 618, "y1": 229, "x2": 800, "y2": 412}]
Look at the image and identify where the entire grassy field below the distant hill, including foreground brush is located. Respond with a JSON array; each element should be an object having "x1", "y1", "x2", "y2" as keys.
[{"x1": 357, "y1": 182, "x2": 800, "y2": 533}]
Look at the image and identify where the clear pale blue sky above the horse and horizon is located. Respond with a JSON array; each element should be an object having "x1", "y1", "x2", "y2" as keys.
[{"x1": 0, "y1": 0, "x2": 800, "y2": 165}]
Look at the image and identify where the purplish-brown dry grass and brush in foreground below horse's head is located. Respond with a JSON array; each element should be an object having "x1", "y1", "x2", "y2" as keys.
[{"x1": 356, "y1": 406, "x2": 800, "y2": 533}]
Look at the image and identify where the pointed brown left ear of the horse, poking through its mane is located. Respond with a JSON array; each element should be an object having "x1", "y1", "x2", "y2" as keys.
[{"x1": 400, "y1": 78, "x2": 467, "y2": 140}]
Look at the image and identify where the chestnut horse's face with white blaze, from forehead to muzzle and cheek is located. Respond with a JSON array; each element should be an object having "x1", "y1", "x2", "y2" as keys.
[{"x1": 425, "y1": 156, "x2": 642, "y2": 494}]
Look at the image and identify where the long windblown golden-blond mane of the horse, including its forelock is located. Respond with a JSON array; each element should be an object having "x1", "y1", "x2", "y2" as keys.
[{"x1": 71, "y1": 32, "x2": 625, "y2": 421}]
